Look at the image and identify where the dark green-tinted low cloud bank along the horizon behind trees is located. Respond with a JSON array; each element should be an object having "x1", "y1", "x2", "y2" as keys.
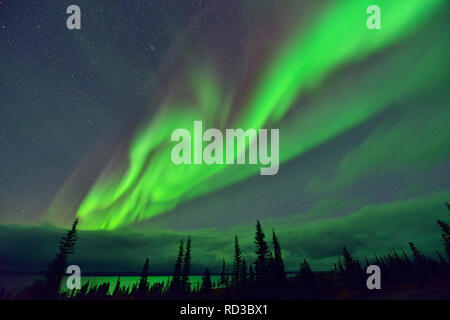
[{"x1": 0, "y1": 192, "x2": 448, "y2": 272}]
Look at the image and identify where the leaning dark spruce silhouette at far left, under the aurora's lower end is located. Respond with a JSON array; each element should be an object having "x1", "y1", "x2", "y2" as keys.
[{"x1": 43, "y1": 219, "x2": 78, "y2": 298}]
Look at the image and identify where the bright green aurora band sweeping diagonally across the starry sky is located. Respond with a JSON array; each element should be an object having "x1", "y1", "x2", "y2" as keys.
[{"x1": 50, "y1": 0, "x2": 448, "y2": 230}]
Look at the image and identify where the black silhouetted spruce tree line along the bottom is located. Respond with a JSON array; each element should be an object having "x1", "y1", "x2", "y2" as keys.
[{"x1": 0, "y1": 203, "x2": 450, "y2": 299}]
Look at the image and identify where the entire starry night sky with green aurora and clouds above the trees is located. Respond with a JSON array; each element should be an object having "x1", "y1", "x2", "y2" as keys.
[{"x1": 0, "y1": 0, "x2": 450, "y2": 271}]
